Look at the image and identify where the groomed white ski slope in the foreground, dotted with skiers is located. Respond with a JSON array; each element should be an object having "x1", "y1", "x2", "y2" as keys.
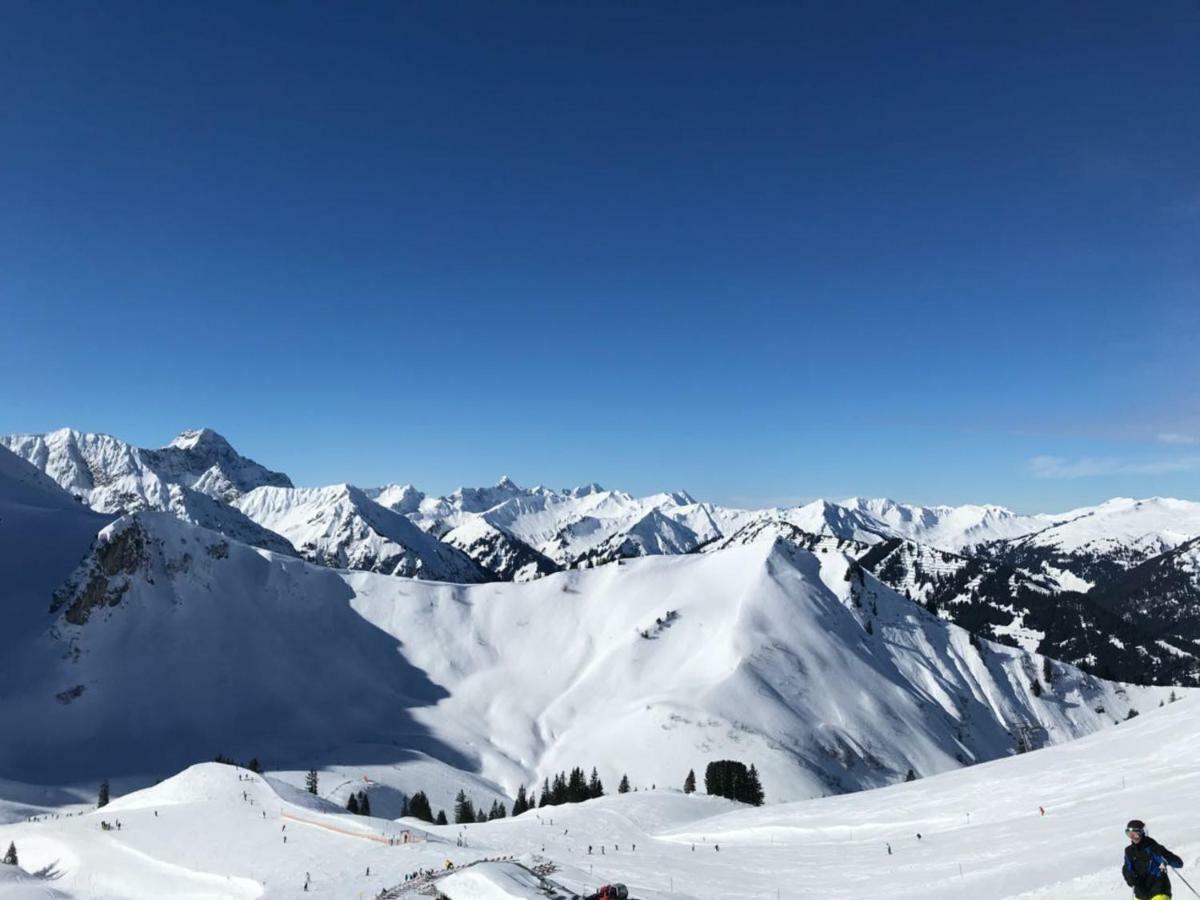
[{"x1": 0, "y1": 698, "x2": 1200, "y2": 900}]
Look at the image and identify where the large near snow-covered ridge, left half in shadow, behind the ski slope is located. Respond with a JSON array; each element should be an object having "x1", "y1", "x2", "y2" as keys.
[{"x1": 0, "y1": 453, "x2": 1165, "y2": 799}]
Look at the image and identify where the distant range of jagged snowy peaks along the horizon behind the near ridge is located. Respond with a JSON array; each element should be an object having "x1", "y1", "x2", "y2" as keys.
[{"x1": 7, "y1": 428, "x2": 1200, "y2": 684}]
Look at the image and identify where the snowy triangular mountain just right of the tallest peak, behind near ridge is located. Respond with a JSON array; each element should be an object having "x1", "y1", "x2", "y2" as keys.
[{"x1": 233, "y1": 485, "x2": 490, "y2": 583}]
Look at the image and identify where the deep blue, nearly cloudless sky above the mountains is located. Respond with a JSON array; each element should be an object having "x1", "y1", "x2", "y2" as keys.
[{"x1": 0, "y1": 0, "x2": 1200, "y2": 511}]
